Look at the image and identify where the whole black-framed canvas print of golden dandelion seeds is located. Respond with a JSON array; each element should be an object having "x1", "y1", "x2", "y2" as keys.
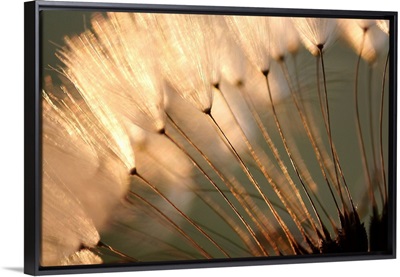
[{"x1": 25, "y1": 1, "x2": 397, "y2": 275}]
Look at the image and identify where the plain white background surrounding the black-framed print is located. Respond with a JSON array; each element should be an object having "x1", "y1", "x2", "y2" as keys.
[{"x1": 0, "y1": 0, "x2": 400, "y2": 276}]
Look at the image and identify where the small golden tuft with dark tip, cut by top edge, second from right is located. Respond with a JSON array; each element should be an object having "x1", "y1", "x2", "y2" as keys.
[{"x1": 292, "y1": 18, "x2": 337, "y2": 56}]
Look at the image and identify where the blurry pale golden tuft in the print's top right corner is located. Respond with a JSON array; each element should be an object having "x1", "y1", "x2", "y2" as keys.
[{"x1": 340, "y1": 19, "x2": 387, "y2": 63}]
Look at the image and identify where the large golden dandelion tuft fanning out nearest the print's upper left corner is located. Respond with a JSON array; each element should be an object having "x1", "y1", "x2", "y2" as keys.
[{"x1": 59, "y1": 13, "x2": 165, "y2": 131}]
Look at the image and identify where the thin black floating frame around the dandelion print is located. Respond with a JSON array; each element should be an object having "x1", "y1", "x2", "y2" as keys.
[{"x1": 24, "y1": 1, "x2": 398, "y2": 275}]
